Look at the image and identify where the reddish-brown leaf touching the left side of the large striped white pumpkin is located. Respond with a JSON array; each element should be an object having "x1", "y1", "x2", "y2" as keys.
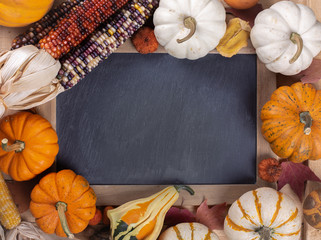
[{"x1": 196, "y1": 200, "x2": 227, "y2": 230}]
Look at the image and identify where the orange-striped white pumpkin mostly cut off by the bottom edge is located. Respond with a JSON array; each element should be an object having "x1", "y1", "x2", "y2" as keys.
[{"x1": 158, "y1": 223, "x2": 219, "y2": 240}]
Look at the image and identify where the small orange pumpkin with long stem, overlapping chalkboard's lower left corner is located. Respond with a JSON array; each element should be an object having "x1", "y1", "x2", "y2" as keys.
[{"x1": 30, "y1": 170, "x2": 97, "y2": 238}]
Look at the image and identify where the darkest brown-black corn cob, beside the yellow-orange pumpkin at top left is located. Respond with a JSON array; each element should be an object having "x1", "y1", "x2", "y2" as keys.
[{"x1": 11, "y1": 0, "x2": 83, "y2": 49}]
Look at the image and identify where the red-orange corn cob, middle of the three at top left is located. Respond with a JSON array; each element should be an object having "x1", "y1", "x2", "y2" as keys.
[{"x1": 39, "y1": 0, "x2": 128, "y2": 59}]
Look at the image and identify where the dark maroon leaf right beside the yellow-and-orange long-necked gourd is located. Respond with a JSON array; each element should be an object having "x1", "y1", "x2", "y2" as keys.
[{"x1": 164, "y1": 207, "x2": 195, "y2": 227}]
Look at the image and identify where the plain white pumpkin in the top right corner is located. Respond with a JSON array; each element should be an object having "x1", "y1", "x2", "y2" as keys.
[{"x1": 251, "y1": 1, "x2": 321, "y2": 75}]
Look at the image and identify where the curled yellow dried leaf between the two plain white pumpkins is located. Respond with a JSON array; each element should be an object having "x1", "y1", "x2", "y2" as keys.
[{"x1": 216, "y1": 18, "x2": 251, "y2": 57}]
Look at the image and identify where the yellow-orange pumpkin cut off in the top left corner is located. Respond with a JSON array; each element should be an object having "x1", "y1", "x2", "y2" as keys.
[{"x1": 0, "y1": 0, "x2": 53, "y2": 27}]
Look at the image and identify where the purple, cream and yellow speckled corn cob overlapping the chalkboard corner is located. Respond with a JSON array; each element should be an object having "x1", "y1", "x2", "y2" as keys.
[{"x1": 57, "y1": 0, "x2": 159, "y2": 89}]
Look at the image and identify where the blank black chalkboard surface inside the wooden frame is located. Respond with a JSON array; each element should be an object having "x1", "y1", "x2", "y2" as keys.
[{"x1": 57, "y1": 53, "x2": 257, "y2": 185}]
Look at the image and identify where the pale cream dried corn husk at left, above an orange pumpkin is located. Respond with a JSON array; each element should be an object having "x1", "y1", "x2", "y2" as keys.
[{"x1": 0, "y1": 45, "x2": 64, "y2": 117}]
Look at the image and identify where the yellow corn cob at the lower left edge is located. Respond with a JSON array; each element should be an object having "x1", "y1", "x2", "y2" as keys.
[{"x1": 0, "y1": 172, "x2": 21, "y2": 229}]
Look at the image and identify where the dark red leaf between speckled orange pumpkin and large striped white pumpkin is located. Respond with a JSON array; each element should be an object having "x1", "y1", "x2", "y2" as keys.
[{"x1": 278, "y1": 161, "x2": 321, "y2": 200}]
